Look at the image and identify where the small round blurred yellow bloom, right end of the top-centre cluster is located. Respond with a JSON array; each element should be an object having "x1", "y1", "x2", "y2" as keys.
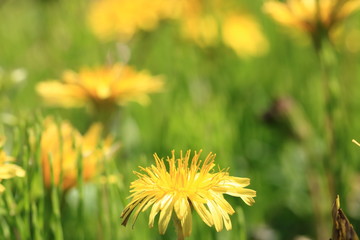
[{"x1": 222, "y1": 14, "x2": 268, "y2": 57}]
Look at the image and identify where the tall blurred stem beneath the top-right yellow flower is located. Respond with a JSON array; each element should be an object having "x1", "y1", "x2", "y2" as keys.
[{"x1": 314, "y1": 25, "x2": 340, "y2": 238}]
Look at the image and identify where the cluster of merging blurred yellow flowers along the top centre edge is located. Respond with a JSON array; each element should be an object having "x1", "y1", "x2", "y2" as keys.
[{"x1": 89, "y1": 0, "x2": 268, "y2": 57}]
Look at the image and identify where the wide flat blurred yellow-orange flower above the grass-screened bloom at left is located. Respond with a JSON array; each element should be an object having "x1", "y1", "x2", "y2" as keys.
[{"x1": 36, "y1": 64, "x2": 163, "y2": 109}]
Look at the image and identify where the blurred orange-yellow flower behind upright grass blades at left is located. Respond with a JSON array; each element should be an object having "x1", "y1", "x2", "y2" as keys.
[{"x1": 41, "y1": 117, "x2": 113, "y2": 190}]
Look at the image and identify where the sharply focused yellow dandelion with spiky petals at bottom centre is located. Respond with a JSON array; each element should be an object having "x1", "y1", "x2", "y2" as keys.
[{"x1": 121, "y1": 150, "x2": 256, "y2": 237}]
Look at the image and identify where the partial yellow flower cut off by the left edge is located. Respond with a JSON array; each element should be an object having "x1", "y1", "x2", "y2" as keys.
[{"x1": 0, "y1": 137, "x2": 25, "y2": 193}]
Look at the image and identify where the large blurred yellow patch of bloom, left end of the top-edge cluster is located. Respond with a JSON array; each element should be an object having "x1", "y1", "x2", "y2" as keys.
[{"x1": 88, "y1": 0, "x2": 180, "y2": 40}]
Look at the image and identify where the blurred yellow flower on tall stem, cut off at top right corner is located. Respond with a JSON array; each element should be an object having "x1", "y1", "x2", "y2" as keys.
[{"x1": 264, "y1": 0, "x2": 360, "y2": 35}]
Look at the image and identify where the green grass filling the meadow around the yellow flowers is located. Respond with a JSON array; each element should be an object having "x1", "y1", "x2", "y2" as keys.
[{"x1": 0, "y1": 0, "x2": 360, "y2": 240}]
